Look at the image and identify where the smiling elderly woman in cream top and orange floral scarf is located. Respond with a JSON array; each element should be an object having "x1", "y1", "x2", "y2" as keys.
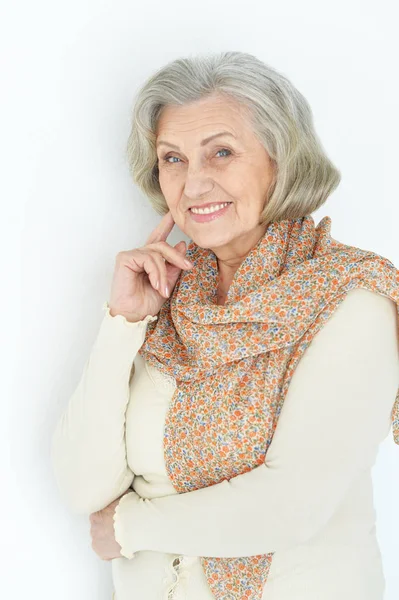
[{"x1": 52, "y1": 52, "x2": 399, "y2": 600}]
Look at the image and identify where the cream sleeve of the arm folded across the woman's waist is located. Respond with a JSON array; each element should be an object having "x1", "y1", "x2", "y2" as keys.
[{"x1": 114, "y1": 288, "x2": 399, "y2": 558}]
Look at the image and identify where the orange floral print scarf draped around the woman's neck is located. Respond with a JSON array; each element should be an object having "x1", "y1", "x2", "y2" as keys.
[{"x1": 139, "y1": 216, "x2": 399, "y2": 600}]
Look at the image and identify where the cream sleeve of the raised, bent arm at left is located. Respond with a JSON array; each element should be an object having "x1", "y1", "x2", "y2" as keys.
[{"x1": 51, "y1": 302, "x2": 158, "y2": 514}]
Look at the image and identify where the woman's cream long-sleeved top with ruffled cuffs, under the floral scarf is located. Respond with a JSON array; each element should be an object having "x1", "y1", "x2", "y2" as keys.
[{"x1": 52, "y1": 288, "x2": 399, "y2": 600}]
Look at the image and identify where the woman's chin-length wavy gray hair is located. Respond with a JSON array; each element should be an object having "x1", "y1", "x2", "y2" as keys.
[{"x1": 127, "y1": 52, "x2": 341, "y2": 224}]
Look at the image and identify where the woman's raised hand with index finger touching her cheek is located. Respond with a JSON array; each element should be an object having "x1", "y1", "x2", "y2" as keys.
[{"x1": 109, "y1": 211, "x2": 193, "y2": 321}]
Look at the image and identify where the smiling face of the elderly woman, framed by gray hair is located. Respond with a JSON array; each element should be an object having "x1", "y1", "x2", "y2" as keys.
[{"x1": 156, "y1": 95, "x2": 274, "y2": 266}]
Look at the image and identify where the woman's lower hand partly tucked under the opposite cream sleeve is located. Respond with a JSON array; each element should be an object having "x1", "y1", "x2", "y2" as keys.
[{"x1": 90, "y1": 489, "x2": 132, "y2": 560}]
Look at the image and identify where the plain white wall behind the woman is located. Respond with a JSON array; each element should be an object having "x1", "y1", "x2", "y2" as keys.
[{"x1": 0, "y1": 0, "x2": 399, "y2": 600}]
